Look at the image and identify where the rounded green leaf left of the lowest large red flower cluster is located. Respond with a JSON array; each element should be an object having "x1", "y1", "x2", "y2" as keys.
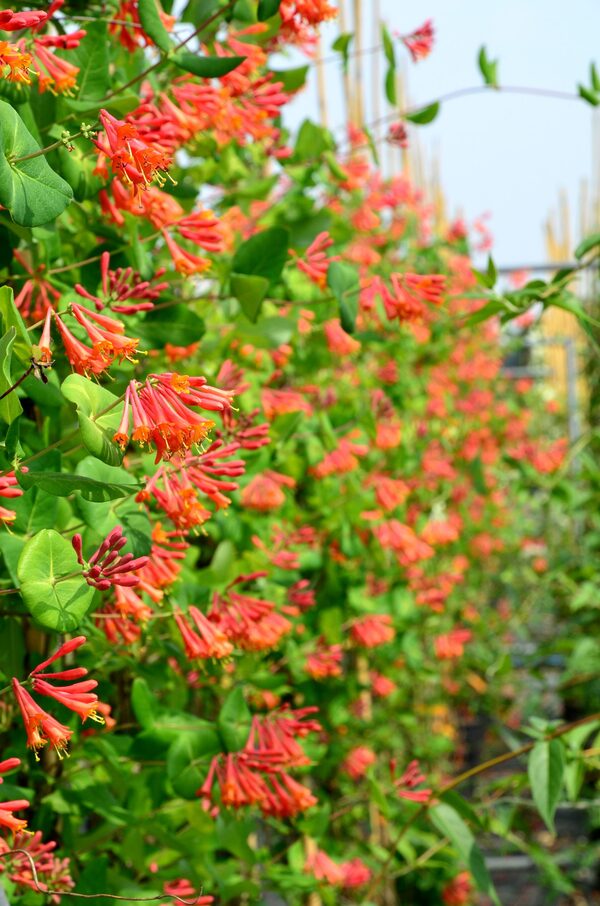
[{"x1": 167, "y1": 721, "x2": 221, "y2": 799}]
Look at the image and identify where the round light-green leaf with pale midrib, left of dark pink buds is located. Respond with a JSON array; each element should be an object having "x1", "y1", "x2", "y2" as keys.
[{"x1": 17, "y1": 529, "x2": 94, "y2": 632}]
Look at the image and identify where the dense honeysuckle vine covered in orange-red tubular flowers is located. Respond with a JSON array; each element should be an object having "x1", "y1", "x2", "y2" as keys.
[{"x1": 0, "y1": 0, "x2": 600, "y2": 906}]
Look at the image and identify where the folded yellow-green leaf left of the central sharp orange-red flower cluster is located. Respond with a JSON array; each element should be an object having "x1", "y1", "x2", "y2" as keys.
[{"x1": 61, "y1": 374, "x2": 123, "y2": 466}]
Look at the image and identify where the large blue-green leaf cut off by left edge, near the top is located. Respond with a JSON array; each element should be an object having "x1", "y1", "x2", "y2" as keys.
[{"x1": 0, "y1": 101, "x2": 73, "y2": 227}]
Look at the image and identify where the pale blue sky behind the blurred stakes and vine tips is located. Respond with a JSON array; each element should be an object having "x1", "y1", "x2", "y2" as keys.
[{"x1": 281, "y1": 0, "x2": 600, "y2": 266}]
